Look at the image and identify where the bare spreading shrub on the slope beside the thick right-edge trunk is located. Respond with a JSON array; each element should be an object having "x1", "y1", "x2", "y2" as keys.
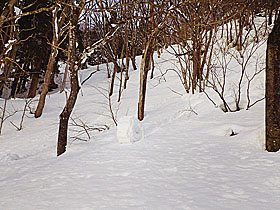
[{"x1": 205, "y1": 20, "x2": 266, "y2": 112}]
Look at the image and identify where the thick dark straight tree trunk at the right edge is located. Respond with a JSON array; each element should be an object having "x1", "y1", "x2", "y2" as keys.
[{"x1": 265, "y1": 16, "x2": 280, "y2": 152}]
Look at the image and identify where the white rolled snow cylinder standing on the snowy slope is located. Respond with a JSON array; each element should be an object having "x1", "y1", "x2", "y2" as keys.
[{"x1": 117, "y1": 116, "x2": 144, "y2": 144}]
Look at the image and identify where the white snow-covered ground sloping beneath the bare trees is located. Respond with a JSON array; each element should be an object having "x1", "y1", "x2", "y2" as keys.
[{"x1": 0, "y1": 43, "x2": 280, "y2": 210}]
